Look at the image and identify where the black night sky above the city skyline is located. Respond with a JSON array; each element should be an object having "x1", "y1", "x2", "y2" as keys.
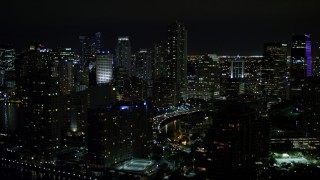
[{"x1": 0, "y1": 0, "x2": 320, "y2": 55}]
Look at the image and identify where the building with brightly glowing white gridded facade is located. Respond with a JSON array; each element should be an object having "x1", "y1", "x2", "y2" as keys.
[{"x1": 96, "y1": 52, "x2": 113, "y2": 84}]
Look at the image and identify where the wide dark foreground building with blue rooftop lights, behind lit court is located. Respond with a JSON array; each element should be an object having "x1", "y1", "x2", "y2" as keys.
[{"x1": 88, "y1": 101, "x2": 152, "y2": 168}]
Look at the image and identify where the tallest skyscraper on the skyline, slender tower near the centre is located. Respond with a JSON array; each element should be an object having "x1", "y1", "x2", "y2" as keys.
[{"x1": 167, "y1": 22, "x2": 187, "y2": 104}]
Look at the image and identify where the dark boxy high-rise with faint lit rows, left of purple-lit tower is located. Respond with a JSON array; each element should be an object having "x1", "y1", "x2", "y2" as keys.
[{"x1": 261, "y1": 43, "x2": 288, "y2": 98}]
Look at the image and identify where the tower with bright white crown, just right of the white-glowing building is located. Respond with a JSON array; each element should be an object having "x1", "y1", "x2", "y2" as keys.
[{"x1": 114, "y1": 36, "x2": 132, "y2": 78}]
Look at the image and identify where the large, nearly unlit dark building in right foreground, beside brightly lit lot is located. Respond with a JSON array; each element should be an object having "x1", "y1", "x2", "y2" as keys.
[{"x1": 205, "y1": 101, "x2": 270, "y2": 179}]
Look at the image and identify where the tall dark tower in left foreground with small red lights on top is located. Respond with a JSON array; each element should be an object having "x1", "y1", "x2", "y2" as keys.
[{"x1": 16, "y1": 42, "x2": 62, "y2": 160}]
